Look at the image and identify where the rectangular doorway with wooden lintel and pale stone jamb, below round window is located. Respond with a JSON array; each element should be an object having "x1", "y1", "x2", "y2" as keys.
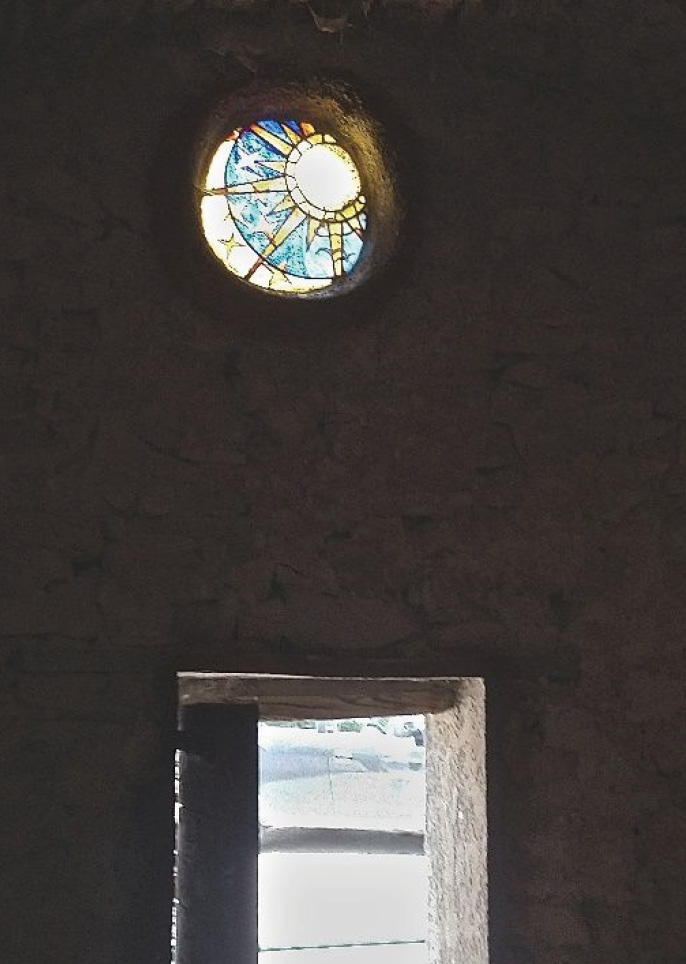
[{"x1": 172, "y1": 673, "x2": 488, "y2": 964}]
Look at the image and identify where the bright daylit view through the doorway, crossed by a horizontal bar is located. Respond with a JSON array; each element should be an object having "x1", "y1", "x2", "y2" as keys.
[{"x1": 258, "y1": 716, "x2": 428, "y2": 964}]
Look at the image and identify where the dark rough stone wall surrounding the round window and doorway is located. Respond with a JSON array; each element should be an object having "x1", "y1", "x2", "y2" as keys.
[{"x1": 0, "y1": 0, "x2": 686, "y2": 964}]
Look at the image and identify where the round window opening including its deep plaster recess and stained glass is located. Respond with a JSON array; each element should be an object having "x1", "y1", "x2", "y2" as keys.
[{"x1": 189, "y1": 80, "x2": 402, "y2": 304}]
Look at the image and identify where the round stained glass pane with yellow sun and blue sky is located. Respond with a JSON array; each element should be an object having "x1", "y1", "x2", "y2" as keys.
[{"x1": 200, "y1": 118, "x2": 367, "y2": 295}]
